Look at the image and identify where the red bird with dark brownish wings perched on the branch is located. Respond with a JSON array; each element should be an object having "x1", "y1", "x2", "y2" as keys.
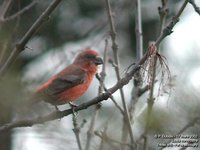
[{"x1": 34, "y1": 49, "x2": 103, "y2": 106}]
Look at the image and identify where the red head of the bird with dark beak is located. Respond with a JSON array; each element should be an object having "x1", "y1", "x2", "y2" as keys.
[{"x1": 73, "y1": 49, "x2": 103, "y2": 72}]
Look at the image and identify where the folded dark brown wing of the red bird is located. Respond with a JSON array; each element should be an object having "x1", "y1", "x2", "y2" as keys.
[{"x1": 46, "y1": 67, "x2": 86, "y2": 95}]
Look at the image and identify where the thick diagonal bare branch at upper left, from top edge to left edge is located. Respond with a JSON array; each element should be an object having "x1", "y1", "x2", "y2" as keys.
[{"x1": 0, "y1": 0, "x2": 61, "y2": 77}]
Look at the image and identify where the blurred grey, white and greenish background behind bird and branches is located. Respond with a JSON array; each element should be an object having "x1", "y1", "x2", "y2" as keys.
[{"x1": 0, "y1": 0, "x2": 200, "y2": 150}]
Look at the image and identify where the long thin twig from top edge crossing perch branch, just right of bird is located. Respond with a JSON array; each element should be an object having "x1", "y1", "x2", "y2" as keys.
[{"x1": 106, "y1": 0, "x2": 134, "y2": 148}]
